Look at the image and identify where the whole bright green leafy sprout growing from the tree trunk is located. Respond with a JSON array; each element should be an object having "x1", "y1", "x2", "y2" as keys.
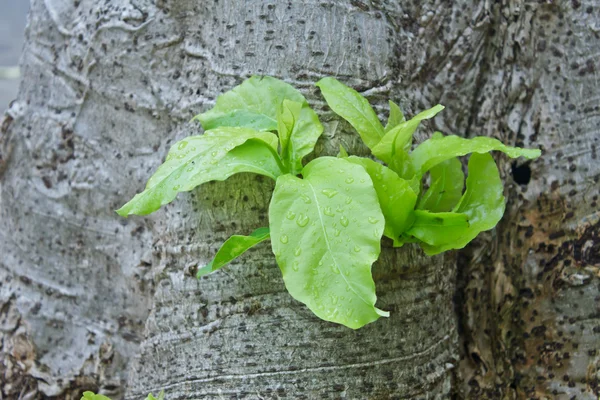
[{"x1": 117, "y1": 77, "x2": 540, "y2": 329}]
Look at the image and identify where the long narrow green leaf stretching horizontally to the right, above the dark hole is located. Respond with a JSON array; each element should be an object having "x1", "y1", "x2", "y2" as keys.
[{"x1": 410, "y1": 135, "x2": 541, "y2": 175}]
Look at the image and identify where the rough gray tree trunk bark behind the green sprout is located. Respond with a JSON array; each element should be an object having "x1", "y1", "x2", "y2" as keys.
[{"x1": 0, "y1": 0, "x2": 600, "y2": 399}]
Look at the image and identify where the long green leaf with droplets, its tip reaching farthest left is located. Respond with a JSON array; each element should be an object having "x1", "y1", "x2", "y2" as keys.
[{"x1": 117, "y1": 127, "x2": 283, "y2": 217}]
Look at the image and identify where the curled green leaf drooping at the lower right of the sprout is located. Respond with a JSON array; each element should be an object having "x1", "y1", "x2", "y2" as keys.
[{"x1": 422, "y1": 153, "x2": 504, "y2": 255}]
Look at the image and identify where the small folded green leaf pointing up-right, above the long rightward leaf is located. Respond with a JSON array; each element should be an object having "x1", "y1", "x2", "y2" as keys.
[{"x1": 372, "y1": 104, "x2": 444, "y2": 164}]
